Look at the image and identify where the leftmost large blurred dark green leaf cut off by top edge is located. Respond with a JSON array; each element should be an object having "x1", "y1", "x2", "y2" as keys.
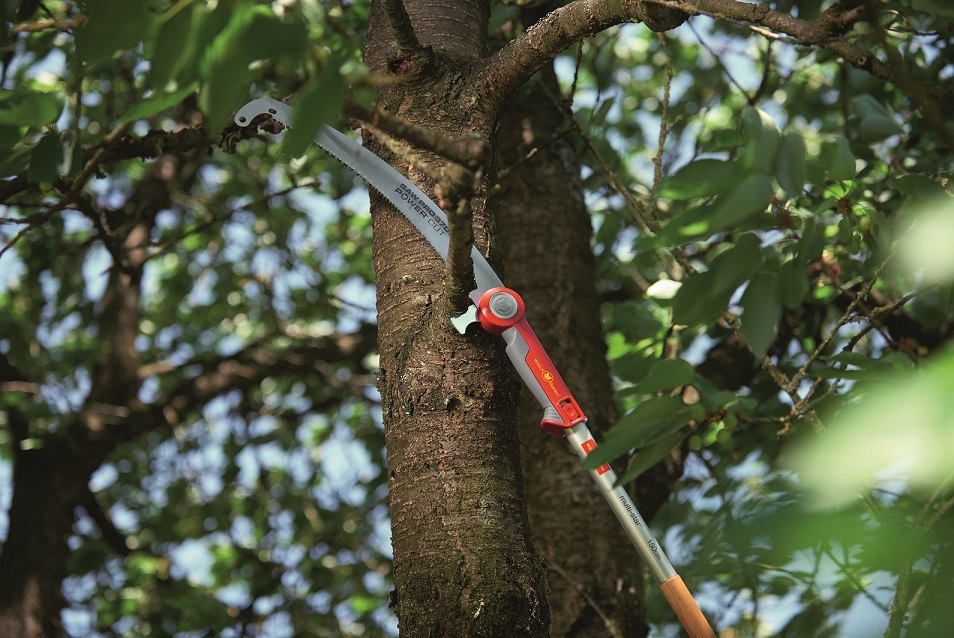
[{"x1": 76, "y1": 0, "x2": 153, "y2": 65}]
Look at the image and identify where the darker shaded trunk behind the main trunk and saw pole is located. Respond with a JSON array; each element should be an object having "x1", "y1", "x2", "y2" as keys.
[{"x1": 499, "y1": 71, "x2": 647, "y2": 637}]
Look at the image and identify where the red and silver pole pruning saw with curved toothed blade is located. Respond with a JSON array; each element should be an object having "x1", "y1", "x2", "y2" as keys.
[{"x1": 235, "y1": 98, "x2": 715, "y2": 638}]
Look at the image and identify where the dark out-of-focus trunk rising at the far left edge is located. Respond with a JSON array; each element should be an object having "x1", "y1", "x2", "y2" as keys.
[{"x1": 0, "y1": 182, "x2": 150, "y2": 638}]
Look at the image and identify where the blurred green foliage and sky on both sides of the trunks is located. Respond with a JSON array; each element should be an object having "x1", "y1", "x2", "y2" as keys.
[{"x1": 0, "y1": 0, "x2": 954, "y2": 637}]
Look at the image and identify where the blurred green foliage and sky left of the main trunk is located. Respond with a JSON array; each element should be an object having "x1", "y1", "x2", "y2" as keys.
[{"x1": 0, "y1": 0, "x2": 393, "y2": 636}]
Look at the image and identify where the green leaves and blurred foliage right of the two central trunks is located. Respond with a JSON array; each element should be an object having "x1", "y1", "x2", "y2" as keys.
[{"x1": 564, "y1": 3, "x2": 954, "y2": 636}]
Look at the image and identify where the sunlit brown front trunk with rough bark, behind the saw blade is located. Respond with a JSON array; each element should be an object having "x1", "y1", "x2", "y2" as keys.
[{"x1": 366, "y1": 1, "x2": 549, "y2": 637}]
